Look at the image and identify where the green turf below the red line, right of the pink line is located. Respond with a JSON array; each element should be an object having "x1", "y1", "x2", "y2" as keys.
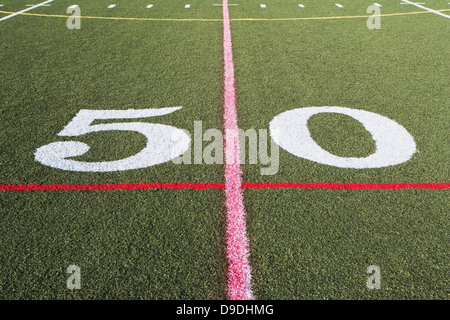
[{"x1": 245, "y1": 190, "x2": 450, "y2": 300}]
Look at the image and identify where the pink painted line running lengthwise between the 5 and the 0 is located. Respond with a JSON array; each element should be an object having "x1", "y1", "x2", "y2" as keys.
[{"x1": 223, "y1": 0, "x2": 253, "y2": 300}]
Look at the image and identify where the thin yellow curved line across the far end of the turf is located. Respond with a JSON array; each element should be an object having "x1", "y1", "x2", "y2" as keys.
[{"x1": 0, "y1": 9, "x2": 450, "y2": 22}]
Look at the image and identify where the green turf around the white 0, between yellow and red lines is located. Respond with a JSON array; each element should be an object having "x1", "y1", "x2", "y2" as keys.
[{"x1": 232, "y1": 5, "x2": 450, "y2": 182}]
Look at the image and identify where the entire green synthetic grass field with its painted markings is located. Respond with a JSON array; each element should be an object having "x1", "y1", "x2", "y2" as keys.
[{"x1": 0, "y1": 0, "x2": 450, "y2": 300}]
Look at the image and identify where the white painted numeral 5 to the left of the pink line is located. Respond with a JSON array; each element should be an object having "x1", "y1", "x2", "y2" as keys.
[{"x1": 34, "y1": 107, "x2": 191, "y2": 172}]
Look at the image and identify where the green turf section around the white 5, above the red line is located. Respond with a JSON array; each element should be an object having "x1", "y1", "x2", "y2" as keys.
[{"x1": 0, "y1": 1, "x2": 222, "y2": 183}]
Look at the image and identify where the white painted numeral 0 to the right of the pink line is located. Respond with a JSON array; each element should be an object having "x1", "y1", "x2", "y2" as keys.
[{"x1": 270, "y1": 107, "x2": 416, "y2": 169}]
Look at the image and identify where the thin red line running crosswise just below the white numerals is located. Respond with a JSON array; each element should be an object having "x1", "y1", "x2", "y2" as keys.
[{"x1": 0, "y1": 182, "x2": 450, "y2": 191}]
